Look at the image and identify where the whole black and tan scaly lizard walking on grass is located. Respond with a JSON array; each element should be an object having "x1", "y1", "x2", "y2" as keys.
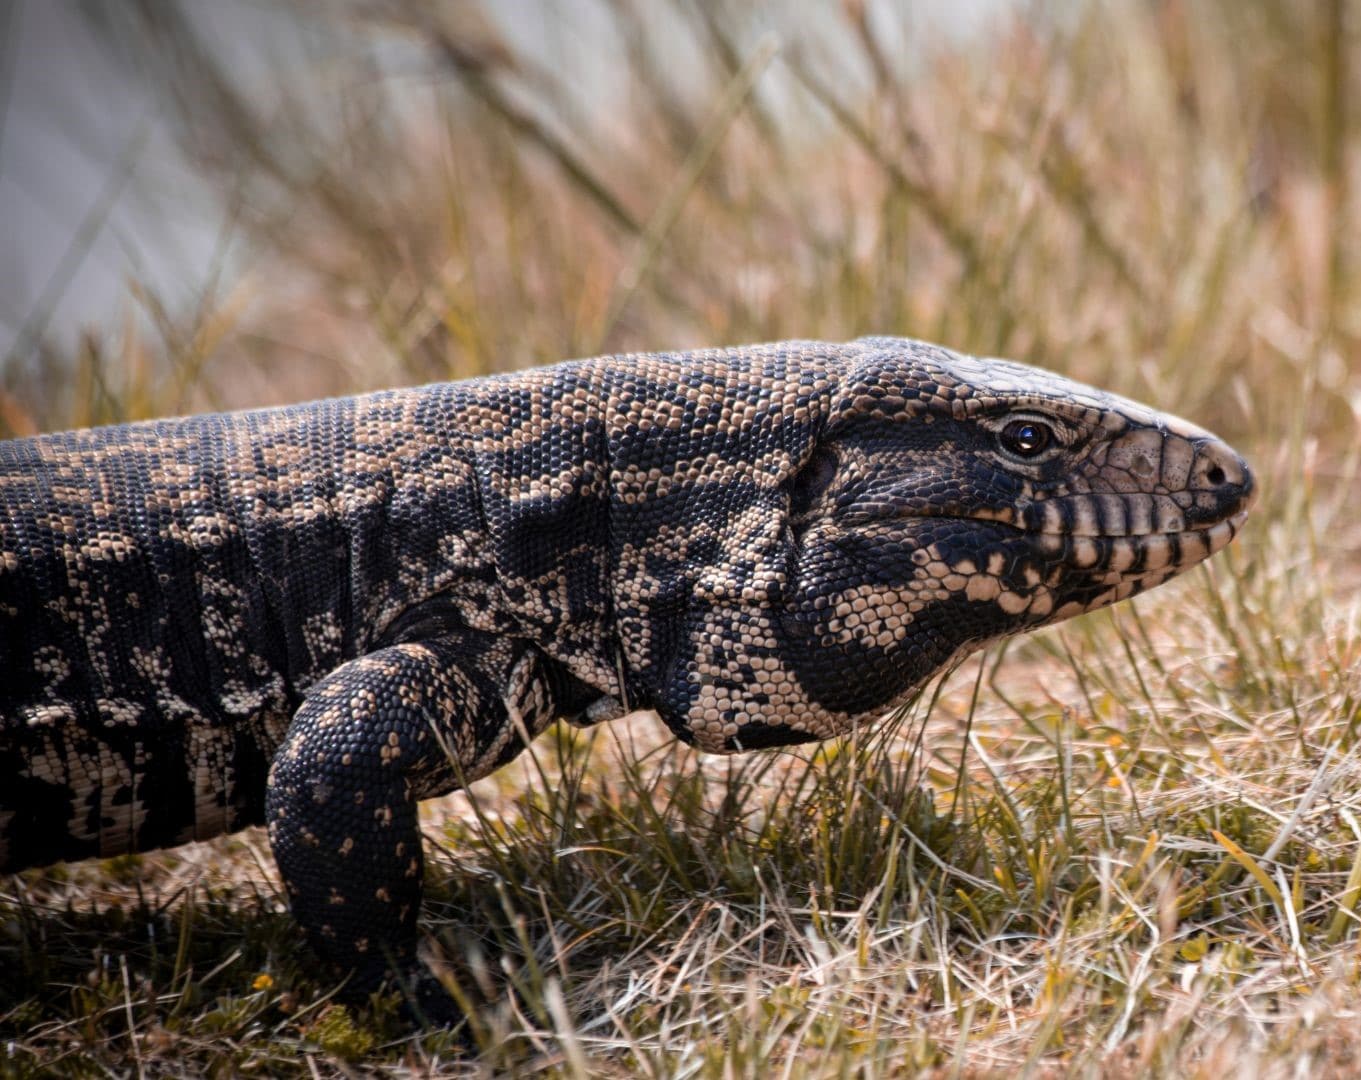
[{"x1": 0, "y1": 339, "x2": 1252, "y2": 1007}]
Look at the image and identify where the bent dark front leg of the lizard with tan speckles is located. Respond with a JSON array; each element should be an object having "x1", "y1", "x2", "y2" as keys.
[{"x1": 267, "y1": 635, "x2": 533, "y2": 1022}]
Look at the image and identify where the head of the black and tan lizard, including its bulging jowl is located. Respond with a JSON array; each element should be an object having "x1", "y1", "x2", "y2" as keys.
[{"x1": 647, "y1": 339, "x2": 1255, "y2": 751}]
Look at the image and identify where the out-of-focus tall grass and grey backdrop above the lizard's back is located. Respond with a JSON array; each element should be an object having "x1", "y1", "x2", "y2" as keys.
[{"x1": 0, "y1": 0, "x2": 1361, "y2": 467}]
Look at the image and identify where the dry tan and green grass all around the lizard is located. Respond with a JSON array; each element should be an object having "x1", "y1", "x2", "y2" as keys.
[{"x1": 0, "y1": 0, "x2": 1361, "y2": 1077}]
